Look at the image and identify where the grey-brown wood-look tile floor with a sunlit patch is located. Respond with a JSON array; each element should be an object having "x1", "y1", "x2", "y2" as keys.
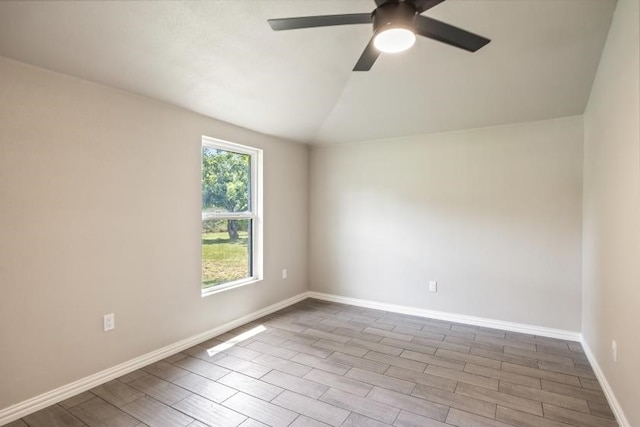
[{"x1": 2, "y1": 299, "x2": 617, "y2": 427}]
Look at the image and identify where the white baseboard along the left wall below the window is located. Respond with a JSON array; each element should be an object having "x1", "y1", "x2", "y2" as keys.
[{"x1": 0, "y1": 292, "x2": 309, "y2": 425}]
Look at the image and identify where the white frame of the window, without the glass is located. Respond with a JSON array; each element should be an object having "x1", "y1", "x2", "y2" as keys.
[{"x1": 200, "y1": 136, "x2": 264, "y2": 297}]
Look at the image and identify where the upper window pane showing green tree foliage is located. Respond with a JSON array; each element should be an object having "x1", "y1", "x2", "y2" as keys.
[{"x1": 202, "y1": 146, "x2": 252, "y2": 213}]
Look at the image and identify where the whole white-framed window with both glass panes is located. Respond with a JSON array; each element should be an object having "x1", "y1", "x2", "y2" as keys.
[{"x1": 202, "y1": 137, "x2": 262, "y2": 296}]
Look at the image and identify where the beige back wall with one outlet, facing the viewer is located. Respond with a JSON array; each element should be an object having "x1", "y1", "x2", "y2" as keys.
[{"x1": 310, "y1": 117, "x2": 583, "y2": 331}]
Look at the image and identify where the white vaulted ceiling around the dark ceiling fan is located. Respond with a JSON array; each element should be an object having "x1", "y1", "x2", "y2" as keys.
[{"x1": 0, "y1": 0, "x2": 615, "y2": 143}]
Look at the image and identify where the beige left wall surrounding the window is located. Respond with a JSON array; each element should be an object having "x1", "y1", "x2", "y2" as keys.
[{"x1": 0, "y1": 55, "x2": 308, "y2": 408}]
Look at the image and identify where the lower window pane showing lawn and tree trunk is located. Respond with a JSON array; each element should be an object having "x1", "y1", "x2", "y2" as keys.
[{"x1": 202, "y1": 219, "x2": 252, "y2": 289}]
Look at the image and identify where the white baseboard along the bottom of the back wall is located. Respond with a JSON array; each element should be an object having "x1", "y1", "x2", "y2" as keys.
[{"x1": 308, "y1": 291, "x2": 581, "y2": 341}]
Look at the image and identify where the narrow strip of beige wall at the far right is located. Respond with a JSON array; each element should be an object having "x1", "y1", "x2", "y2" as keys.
[{"x1": 582, "y1": 0, "x2": 640, "y2": 426}]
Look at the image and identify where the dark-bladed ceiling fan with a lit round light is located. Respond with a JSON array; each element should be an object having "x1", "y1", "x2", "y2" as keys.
[{"x1": 267, "y1": 0, "x2": 491, "y2": 71}]
